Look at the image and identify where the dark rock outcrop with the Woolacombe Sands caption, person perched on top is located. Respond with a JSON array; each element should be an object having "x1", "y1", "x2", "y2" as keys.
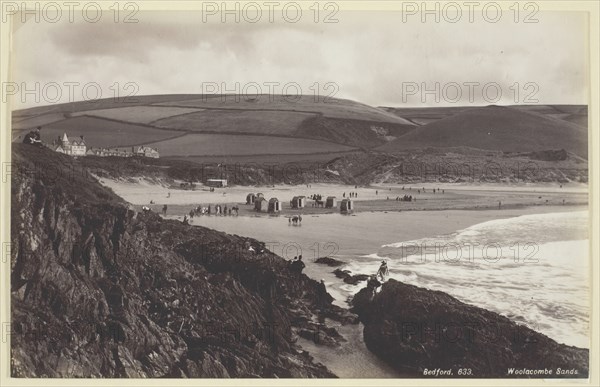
[{"x1": 353, "y1": 280, "x2": 589, "y2": 378}]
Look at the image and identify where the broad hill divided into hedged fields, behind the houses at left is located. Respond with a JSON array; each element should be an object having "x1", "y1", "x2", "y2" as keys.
[{"x1": 12, "y1": 95, "x2": 414, "y2": 159}]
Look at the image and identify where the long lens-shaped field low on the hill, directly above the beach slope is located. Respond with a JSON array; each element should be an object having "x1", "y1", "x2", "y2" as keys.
[{"x1": 144, "y1": 134, "x2": 360, "y2": 156}]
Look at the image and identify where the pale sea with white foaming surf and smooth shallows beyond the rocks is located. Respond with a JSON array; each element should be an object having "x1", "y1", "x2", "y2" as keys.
[{"x1": 194, "y1": 209, "x2": 590, "y2": 348}]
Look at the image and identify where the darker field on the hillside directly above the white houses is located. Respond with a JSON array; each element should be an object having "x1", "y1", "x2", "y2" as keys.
[{"x1": 42, "y1": 117, "x2": 181, "y2": 148}]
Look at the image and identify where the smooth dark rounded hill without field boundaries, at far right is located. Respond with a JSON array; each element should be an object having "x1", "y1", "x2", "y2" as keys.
[{"x1": 377, "y1": 106, "x2": 587, "y2": 157}]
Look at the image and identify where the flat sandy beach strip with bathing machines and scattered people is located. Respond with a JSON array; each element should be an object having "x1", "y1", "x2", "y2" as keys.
[{"x1": 101, "y1": 179, "x2": 588, "y2": 217}]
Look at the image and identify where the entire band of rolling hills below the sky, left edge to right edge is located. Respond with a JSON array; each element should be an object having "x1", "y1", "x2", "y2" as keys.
[{"x1": 12, "y1": 98, "x2": 587, "y2": 162}]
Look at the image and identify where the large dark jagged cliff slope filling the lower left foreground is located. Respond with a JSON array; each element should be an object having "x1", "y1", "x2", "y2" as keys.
[{"x1": 11, "y1": 144, "x2": 352, "y2": 377}]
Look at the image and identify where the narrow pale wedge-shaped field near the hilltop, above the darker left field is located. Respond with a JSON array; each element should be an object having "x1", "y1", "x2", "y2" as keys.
[{"x1": 72, "y1": 106, "x2": 199, "y2": 124}]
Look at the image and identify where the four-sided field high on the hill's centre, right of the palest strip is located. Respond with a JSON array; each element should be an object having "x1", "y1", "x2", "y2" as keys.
[{"x1": 153, "y1": 107, "x2": 314, "y2": 135}]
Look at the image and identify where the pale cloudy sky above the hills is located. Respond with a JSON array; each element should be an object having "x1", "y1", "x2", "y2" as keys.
[{"x1": 11, "y1": 7, "x2": 588, "y2": 109}]
